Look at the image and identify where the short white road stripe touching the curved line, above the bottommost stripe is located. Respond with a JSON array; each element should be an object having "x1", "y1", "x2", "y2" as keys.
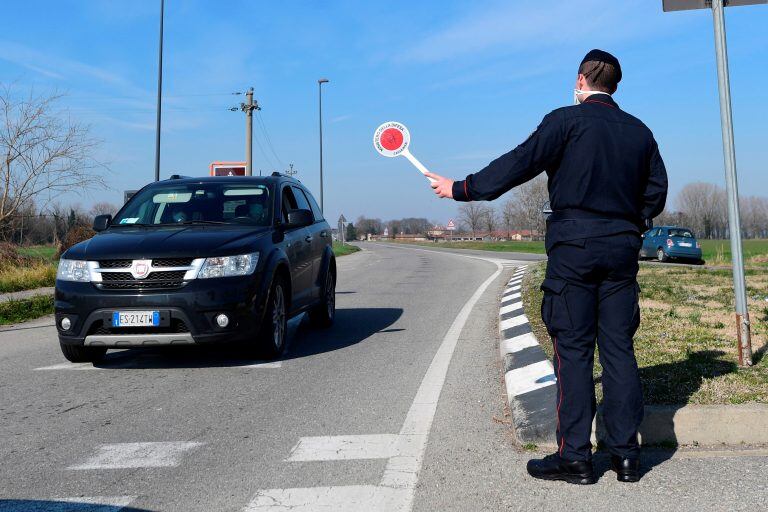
[{"x1": 287, "y1": 434, "x2": 421, "y2": 461}]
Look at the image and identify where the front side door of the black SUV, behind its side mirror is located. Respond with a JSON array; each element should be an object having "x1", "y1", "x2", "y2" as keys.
[{"x1": 280, "y1": 185, "x2": 313, "y2": 309}]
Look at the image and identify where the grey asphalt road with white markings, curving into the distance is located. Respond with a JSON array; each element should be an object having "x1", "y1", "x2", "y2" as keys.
[{"x1": 0, "y1": 244, "x2": 768, "y2": 512}]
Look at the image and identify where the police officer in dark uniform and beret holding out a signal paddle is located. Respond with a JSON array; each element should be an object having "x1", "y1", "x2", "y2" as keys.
[{"x1": 431, "y1": 50, "x2": 667, "y2": 484}]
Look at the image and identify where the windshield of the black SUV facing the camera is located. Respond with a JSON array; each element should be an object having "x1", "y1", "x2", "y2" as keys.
[{"x1": 112, "y1": 183, "x2": 271, "y2": 226}]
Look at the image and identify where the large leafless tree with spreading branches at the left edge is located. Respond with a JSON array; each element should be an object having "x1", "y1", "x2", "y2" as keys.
[{"x1": 0, "y1": 85, "x2": 105, "y2": 228}]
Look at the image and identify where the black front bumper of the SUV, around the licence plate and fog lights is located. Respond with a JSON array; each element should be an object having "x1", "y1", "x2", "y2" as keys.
[{"x1": 54, "y1": 273, "x2": 265, "y2": 347}]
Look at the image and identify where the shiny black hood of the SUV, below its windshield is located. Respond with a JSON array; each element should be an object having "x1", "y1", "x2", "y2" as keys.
[{"x1": 64, "y1": 225, "x2": 270, "y2": 260}]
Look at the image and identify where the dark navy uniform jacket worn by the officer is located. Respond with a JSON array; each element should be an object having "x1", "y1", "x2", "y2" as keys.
[{"x1": 453, "y1": 94, "x2": 667, "y2": 250}]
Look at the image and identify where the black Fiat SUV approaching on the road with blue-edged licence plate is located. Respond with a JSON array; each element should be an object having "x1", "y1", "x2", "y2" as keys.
[{"x1": 55, "y1": 174, "x2": 336, "y2": 362}]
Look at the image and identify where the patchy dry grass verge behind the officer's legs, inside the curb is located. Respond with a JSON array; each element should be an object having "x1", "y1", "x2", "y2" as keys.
[{"x1": 523, "y1": 262, "x2": 768, "y2": 404}]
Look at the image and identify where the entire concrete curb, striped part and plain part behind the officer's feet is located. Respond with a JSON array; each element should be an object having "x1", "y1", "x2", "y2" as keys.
[{"x1": 499, "y1": 266, "x2": 768, "y2": 447}]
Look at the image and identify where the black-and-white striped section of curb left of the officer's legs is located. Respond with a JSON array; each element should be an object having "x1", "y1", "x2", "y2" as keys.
[{"x1": 499, "y1": 266, "x2": 557, "y2": 445}]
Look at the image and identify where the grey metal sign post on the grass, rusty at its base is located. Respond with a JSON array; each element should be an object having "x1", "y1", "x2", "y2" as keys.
[{"x1": 662, "y1": 0, "x2": 768, "y2": 366}]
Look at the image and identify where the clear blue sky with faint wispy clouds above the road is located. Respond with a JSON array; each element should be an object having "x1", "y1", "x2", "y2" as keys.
[{"x1": 0, "y1": 0, "x2": 768, "y2": 222}]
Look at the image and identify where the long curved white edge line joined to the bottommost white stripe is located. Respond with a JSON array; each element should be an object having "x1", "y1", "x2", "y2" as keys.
[{"x1": 244, "y1": 254, "x2": 503, "y2": 512}]
